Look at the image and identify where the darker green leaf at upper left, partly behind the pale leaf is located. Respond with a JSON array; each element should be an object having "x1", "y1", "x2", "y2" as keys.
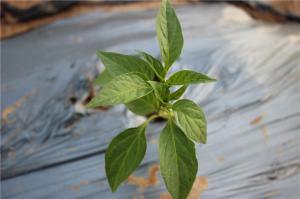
[{"x1": 97, "y1": 52, "x2": 154, "y2": 80}]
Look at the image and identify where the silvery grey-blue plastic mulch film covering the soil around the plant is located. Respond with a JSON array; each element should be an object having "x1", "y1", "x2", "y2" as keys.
[{"x1": 1, "y1": 5, "x2": 300, "y2": 199}]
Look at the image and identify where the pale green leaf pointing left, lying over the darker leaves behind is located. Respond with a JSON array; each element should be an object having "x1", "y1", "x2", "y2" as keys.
[{"x1": 87, "y1": 73, "x2": 152, "y2": 108}]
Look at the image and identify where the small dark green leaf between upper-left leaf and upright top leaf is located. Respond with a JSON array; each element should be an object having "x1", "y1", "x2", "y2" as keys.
[{"x1": 138, "y1": 51, "x2": 166, "y2": 80}]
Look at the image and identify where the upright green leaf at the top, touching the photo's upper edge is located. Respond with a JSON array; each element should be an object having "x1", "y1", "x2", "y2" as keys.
[{"x1": 156, "y1": 0, "x2": 183, "y2": 71}]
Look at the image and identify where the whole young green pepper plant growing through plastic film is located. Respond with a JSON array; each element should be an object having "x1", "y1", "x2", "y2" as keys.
[{"x1": 87, "y1": 0, "x2": 215, "y2": 199}]
